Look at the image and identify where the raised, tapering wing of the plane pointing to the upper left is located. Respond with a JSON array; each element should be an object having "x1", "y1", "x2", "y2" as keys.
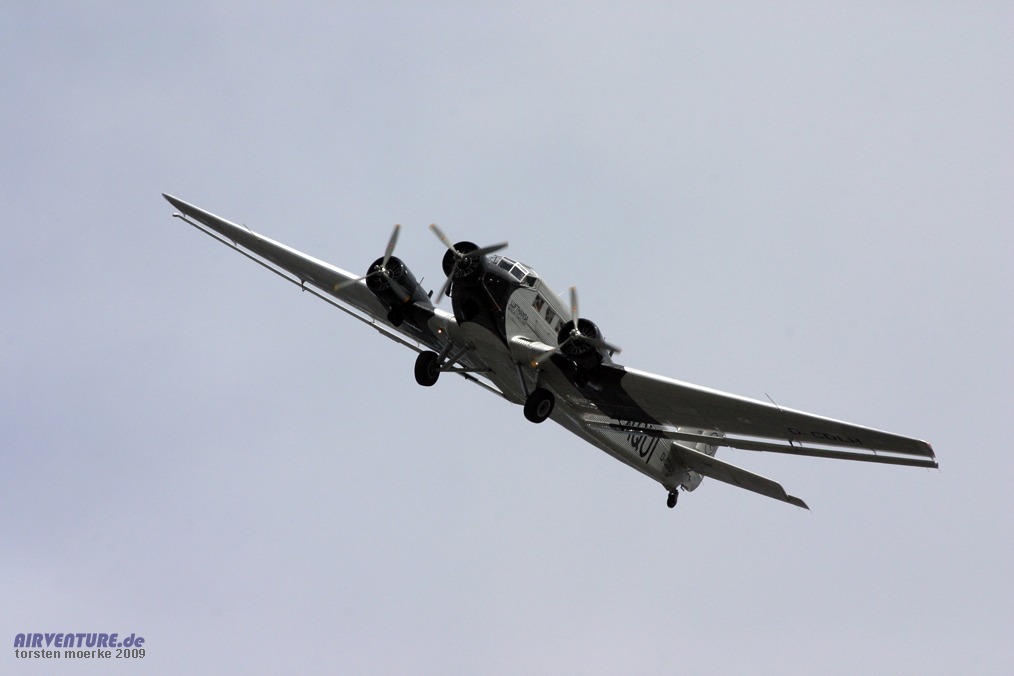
[{"x1": 162, "y1": 193, "x2": 457, "y2": 351}]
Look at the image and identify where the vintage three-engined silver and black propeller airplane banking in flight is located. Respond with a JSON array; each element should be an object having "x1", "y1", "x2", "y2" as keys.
[{"x1": 162, "y1": 193, "x2": 938, "y2": 510}]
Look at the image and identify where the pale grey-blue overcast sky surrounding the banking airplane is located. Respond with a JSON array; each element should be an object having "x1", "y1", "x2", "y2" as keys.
[{"x1": 0, "y1": 2, "x2": 1014, "y2": 674}]
